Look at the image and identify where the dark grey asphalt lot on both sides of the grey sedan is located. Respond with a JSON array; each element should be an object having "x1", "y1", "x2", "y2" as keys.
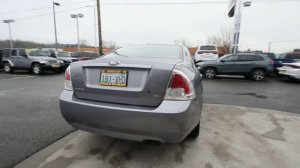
[{"x1": 0, "y1": 72, "x2": 300, "y2": 168}]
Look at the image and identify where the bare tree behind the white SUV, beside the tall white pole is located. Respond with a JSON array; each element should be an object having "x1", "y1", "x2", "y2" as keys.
[{"x1": 207, "y1": 28, "x2": 233, "y2": 54}]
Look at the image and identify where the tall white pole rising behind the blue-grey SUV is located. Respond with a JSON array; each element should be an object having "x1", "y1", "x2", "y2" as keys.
[{"x1": 232, "y1": 0, "x2": 251, "y2": 54}]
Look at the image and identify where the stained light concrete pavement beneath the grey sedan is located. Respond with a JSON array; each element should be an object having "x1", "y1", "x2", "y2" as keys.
[{"x1": 15, "y1": 104, "x2": 300, "y2": 168}]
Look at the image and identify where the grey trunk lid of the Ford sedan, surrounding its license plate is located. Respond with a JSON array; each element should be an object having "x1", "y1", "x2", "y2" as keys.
[{"x1": 72, "y1": 58, "x2": 181, "y2": 106}]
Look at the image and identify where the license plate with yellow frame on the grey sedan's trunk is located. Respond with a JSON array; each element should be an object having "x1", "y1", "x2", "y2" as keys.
[{"x1": 99, "y1": 69, "x2": 128, "y2": 87}]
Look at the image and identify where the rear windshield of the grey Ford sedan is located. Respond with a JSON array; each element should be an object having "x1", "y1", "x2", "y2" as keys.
[{"x1": 105, "y1": 45, "x2": 182, "y2": 59}]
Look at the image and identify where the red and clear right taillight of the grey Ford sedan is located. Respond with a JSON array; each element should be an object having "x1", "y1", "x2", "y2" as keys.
[{"x1": 165, "y1": 70, "x2": 195, "y2": 100}]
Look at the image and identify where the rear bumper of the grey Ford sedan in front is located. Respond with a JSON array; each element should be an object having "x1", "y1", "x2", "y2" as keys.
[{"x1": 60, "y1": 90, "x2": 202, "y2": 143}]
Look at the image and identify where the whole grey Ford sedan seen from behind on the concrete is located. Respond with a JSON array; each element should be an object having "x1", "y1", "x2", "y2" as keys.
[{"x1": 60, "y1": 45, "x2": 202, "y2": 143}]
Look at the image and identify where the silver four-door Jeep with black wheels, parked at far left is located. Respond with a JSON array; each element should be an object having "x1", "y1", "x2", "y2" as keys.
[{"x1": 2, "y1": 48, "x2": 62, "y2": 75}]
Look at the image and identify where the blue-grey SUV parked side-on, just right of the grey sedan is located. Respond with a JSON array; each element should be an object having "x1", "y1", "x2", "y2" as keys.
[{"x1": 197, "y1": 54, "x2": 274, "y2": 81}]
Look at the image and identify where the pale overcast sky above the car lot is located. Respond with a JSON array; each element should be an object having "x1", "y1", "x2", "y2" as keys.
[{"x1": 0, "y1": 0, "x2": 300, "y2": 53}]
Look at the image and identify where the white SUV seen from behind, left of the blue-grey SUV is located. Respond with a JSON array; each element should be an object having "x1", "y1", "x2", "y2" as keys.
[{"x1": 195, "y1": 45, "x2": 219, "y2": 62}]
